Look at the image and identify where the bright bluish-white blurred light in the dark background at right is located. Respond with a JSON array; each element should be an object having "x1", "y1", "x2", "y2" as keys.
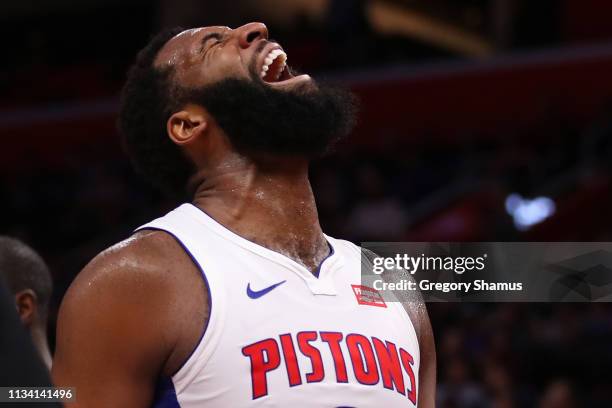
[{"x1": 506, "y1": 193, "x2": 556, "y2": 231}]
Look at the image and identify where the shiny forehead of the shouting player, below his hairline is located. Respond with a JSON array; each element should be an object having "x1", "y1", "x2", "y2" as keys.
[{"x1": 155, "y1": 26, "x2": 231, "y2": 66}]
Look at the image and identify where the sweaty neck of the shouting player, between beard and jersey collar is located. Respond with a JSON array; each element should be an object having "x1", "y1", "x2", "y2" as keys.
[{"x1": 194, "y1": 156, "x2": 329, "y2": 271}]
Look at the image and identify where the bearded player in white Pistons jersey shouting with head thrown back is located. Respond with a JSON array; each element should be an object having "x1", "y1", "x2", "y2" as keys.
[{"x1": 53, "y1": 23, "x2": 435, "y2": 408}]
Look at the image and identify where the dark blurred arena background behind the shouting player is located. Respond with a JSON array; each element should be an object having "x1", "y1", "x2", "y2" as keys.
[{"x1": 0, "y1": 0, "x2": 612, "y2": 408}]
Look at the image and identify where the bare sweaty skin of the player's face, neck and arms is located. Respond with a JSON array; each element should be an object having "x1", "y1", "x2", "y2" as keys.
[{"x1": 52, "y1": 23, "x2": 435, "y2": 408}]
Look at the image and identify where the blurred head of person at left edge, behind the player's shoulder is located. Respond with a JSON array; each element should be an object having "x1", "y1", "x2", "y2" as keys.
[{"x1": 0, "y1": 236, "x2": 53, "y2": 329}]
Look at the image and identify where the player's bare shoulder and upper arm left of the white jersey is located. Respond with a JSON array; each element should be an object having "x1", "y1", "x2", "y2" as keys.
[{"x1": 52, "y1": 231, "x2": 206, "y2": 407}]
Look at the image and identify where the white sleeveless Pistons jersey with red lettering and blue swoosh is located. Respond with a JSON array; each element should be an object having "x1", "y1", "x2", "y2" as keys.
[{"x1": 139, "y1": 204, "x2": 420, "y2": 408}]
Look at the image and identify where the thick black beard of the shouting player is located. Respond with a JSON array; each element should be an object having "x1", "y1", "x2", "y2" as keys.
[{"x1": 177, "y1": 78, "x2": 357, "y2": 158}]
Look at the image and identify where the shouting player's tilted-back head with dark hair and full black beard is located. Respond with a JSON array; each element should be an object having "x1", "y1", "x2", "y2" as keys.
[{"x1": 119, "y1": 23, "x2": 355, "y2": 198}]
